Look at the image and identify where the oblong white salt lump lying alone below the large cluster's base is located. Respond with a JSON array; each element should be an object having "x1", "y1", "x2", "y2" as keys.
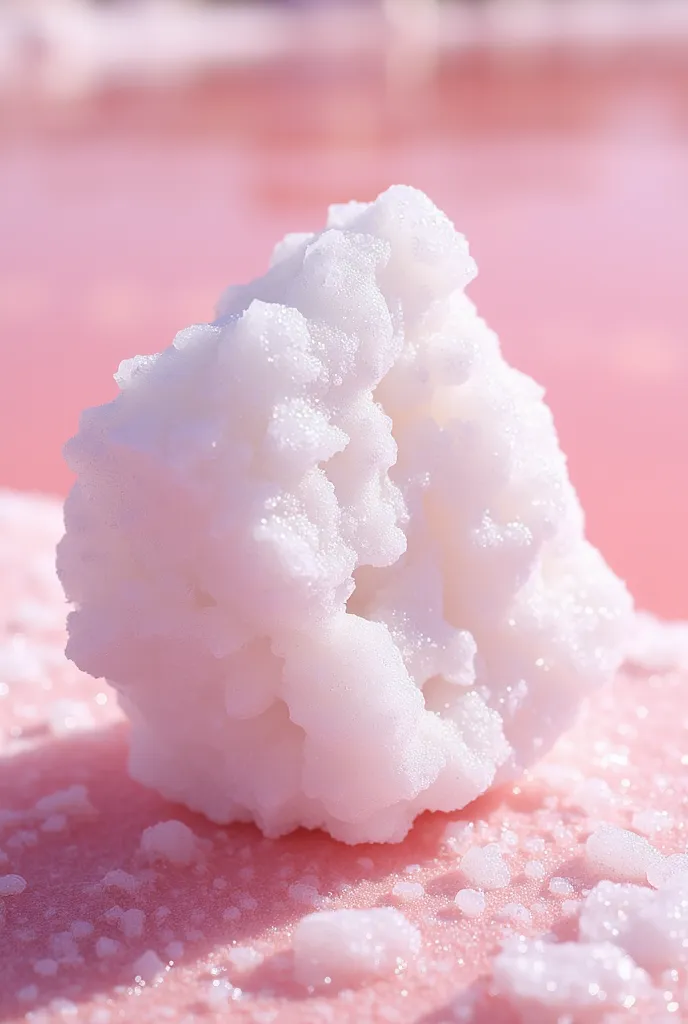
[{"x1": 293, "y1": 907, "x2": 421, "y2": 991}]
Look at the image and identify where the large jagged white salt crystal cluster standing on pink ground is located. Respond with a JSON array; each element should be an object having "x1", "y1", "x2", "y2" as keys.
[{"x1": 58, "y1": 186, "x2": 630, "y2": 843}]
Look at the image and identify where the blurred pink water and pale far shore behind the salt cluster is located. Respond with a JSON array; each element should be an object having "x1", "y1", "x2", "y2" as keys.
[{"x1": 0, "y1": 0, "x2": 688, "y2": 617}]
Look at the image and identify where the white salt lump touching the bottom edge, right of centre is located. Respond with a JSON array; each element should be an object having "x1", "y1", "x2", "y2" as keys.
[{"x1": 493, "y1": 937, "x2": 652, "y2": 1024}]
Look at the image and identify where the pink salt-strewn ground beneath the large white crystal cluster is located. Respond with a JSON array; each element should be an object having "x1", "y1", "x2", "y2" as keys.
[{"x1": 0, "y1": 495, "x2": 688, "y2": 1024}]
